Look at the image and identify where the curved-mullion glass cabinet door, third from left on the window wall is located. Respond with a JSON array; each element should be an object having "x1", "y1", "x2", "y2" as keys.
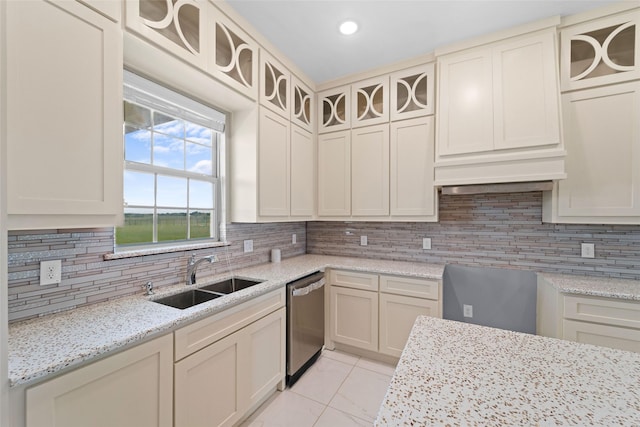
[{"x1": 260, "y1": 49, "x2": 291, "y2": 120}]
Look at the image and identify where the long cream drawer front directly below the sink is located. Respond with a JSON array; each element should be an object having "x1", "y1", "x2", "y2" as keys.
[{"x1": 174, "y1": 288, "x2": 286, "y2": 361}]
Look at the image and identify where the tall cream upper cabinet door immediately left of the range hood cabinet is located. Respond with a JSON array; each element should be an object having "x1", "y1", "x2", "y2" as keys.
[{"x1": 389, "y1": 117, "x2": 438, "y2": 220}]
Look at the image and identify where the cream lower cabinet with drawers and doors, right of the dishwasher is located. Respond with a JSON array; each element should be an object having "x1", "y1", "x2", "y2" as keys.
[{"x1": 328, "y1": 270, "x2": 442, "y2": 357}]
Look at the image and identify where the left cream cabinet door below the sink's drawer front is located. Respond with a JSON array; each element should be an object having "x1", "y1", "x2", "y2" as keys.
[{"x1": 175, "y1": 333, "x2": 247, "y2": 427}]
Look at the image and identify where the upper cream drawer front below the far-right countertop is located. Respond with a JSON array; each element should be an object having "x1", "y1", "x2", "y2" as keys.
[{"x1": 564, "y1": 295, "x2": 640, "y2": 329}]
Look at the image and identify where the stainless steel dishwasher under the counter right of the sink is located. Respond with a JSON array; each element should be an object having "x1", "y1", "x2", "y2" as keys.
[{"x1": 287, "y1": 272, "x2": 324, "y2": 386}]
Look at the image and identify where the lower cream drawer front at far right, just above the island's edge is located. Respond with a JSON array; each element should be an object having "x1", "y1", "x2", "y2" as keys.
[{"x1": 562, "y1": 319, "x2": 640, "y2": 353}]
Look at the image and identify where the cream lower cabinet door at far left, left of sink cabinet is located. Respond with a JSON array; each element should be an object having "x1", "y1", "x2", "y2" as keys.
[{"x1": 26, "y1": 334, "x2": 173, "y2": 427}]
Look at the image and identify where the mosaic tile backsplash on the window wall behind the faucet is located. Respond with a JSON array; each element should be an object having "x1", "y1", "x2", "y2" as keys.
[{"x1": 8, "y1": 222, "x2": 306, "y2": 322}]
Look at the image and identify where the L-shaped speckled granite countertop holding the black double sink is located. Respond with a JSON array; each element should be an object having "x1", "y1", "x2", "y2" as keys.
[{"x1": 8, "y1": 255, "x2": 444, "y2": 386}]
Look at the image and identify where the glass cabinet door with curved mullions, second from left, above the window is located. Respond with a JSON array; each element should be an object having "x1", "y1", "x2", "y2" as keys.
[{"x1": 207, "y1": 4, "x2": 258, "y2": 99}]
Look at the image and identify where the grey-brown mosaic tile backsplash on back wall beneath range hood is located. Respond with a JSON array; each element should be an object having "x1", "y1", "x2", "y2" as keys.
[{"x1": 307, "y1": 192, "x2": 640, "y2": 279}]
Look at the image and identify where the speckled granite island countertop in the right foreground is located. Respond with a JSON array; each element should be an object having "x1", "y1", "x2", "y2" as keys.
[{"x1": 375, "y1": 316, "x2": 640, "y2": 426}]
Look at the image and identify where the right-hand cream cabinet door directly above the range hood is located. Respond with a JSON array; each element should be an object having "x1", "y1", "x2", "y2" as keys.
[{"x1": 493, "y1": 29, "x2": 560, "y2": 149}]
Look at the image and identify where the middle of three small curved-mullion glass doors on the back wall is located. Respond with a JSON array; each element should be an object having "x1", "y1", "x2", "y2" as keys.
[{"x1": 351, "y1": 76, "x2": 389, "y2": 128}]
